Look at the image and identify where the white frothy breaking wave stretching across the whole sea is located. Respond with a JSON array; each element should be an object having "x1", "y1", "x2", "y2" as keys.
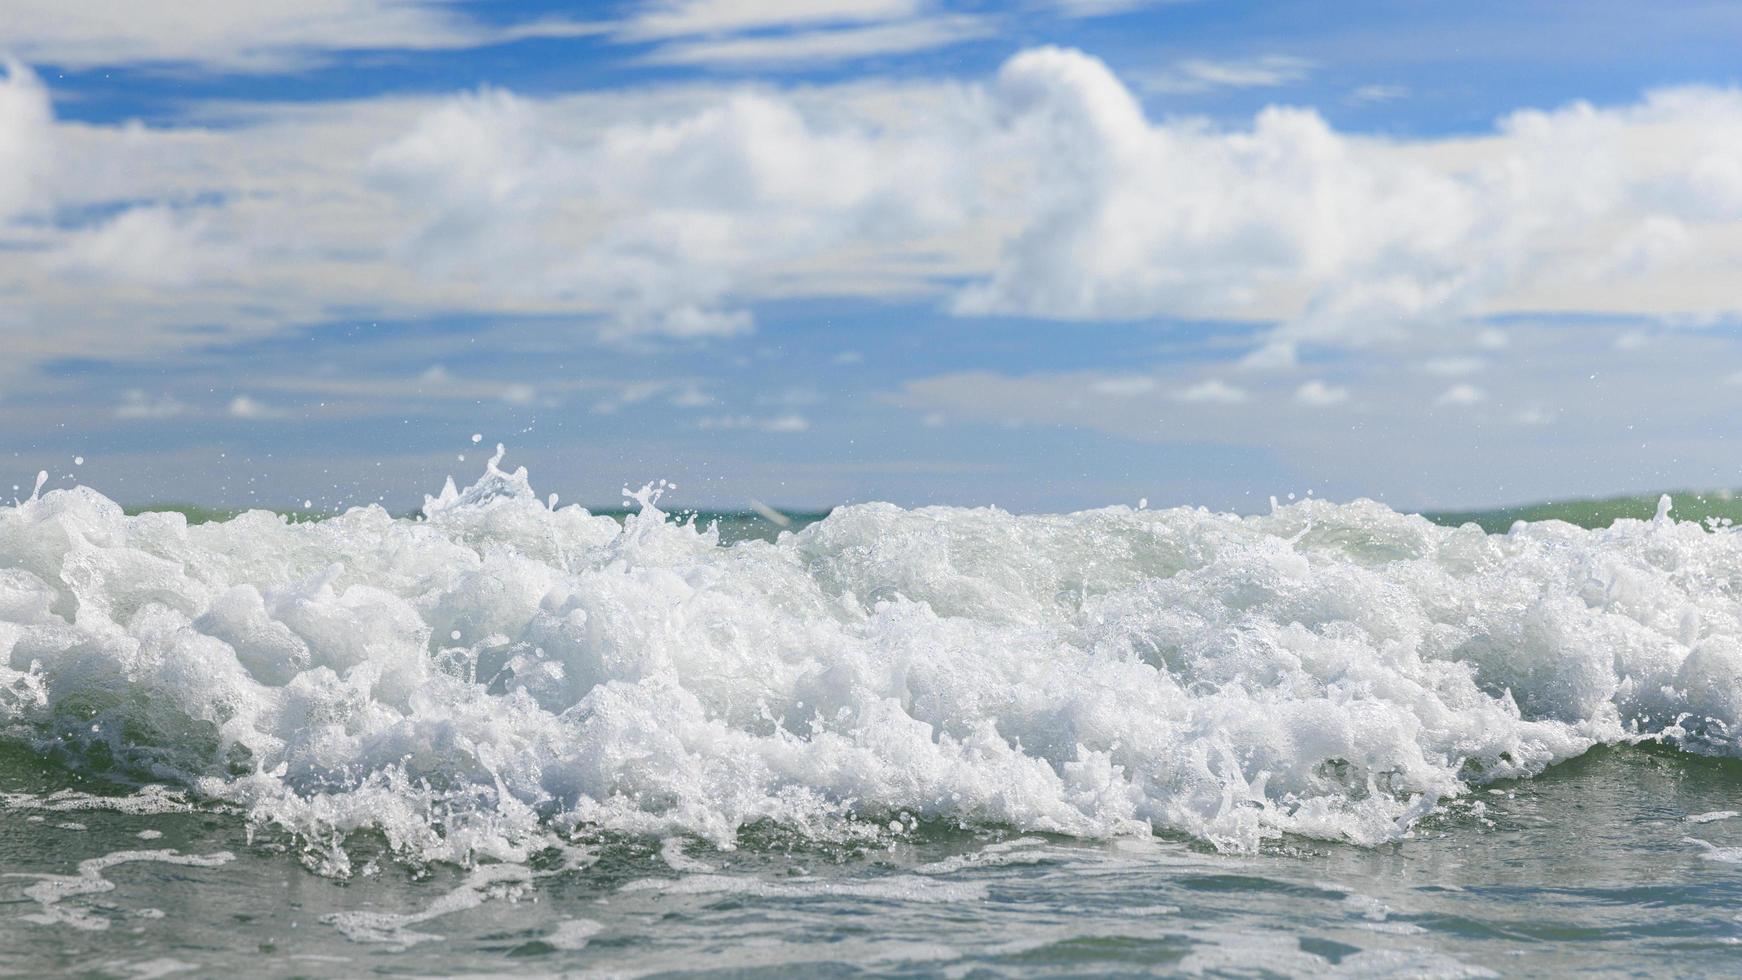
[{"x1": 0, "y1": 453, "x2": 1742, "y2": 872}]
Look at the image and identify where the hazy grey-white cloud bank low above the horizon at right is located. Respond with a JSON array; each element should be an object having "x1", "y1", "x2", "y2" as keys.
[{"x1": 890, "y1": 328, "x2": 1742, "y2": 507}]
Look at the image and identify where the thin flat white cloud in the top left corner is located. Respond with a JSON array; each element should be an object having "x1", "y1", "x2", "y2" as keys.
[{"x1": 5, "y1": 0, "x2": 604, "y2": 71}]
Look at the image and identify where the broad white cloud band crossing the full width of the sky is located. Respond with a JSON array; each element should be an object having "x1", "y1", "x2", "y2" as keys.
[{"x1": 0, "y1": 46, "x2": 1742, "y2": 363}]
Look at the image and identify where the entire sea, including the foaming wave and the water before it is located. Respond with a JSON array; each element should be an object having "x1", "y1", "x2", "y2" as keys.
[{"x1": 0, "y1": 453, "x2": 1742, "y2": 977}]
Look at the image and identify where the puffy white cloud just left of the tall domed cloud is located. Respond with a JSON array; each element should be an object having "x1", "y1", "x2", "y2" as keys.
[{"x1": 369, "y1": 81, "x2": 962, "y2": 338}]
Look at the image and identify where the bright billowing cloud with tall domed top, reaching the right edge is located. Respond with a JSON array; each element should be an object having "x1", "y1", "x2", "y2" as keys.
[{"x1": 956, "y1": 49, "x2": 1742, "y2": 343}]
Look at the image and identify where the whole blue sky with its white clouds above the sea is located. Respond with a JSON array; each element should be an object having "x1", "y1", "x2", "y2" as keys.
[{"x1": 0, "y1": 0, "x2": 1742, "y2": 510}]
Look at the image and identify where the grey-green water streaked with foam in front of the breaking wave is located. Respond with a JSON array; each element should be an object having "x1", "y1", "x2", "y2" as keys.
[{"x1": 0, "y1": 748, "x2": 1742, "y2": 977}]
